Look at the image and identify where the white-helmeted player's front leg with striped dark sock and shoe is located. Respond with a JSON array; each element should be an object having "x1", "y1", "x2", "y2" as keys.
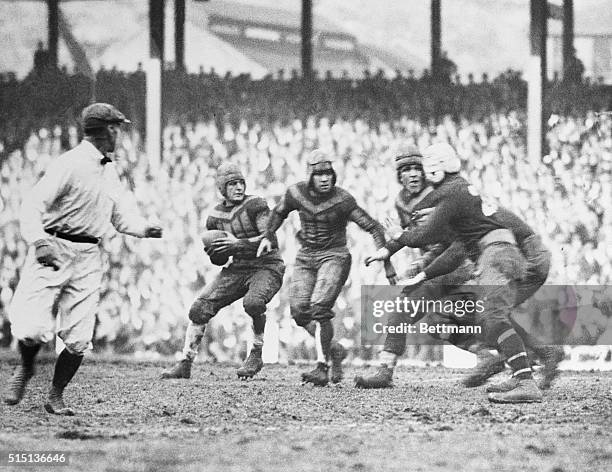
[{"x1": 478, "y1": 244, "x2": 542, "y2": 403}]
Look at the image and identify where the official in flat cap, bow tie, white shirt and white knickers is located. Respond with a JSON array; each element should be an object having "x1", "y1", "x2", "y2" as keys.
[{"x1": 4, "y1": 103, "x2": 162, "y2": 415}]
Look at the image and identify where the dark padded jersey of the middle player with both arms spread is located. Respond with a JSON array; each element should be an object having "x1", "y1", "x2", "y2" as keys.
[{"x1": 266, "y1": 182, "x2": 385, "y2": 249}]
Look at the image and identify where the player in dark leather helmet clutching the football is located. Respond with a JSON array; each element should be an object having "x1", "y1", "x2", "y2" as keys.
[{"x1": 162, "y1": 163, "x2": 285, "y2": 379}]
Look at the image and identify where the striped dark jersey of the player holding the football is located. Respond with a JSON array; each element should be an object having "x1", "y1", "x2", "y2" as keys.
[{"x1": 206, "y1": 195, "x2": 280, "y2": 260}]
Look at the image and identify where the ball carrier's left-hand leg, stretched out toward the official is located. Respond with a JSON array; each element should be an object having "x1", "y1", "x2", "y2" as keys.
[{"x1": 161, "y1": 267, "x2": 247, "y2": 379}]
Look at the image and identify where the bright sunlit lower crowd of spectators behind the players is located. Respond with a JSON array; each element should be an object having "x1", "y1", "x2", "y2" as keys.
[{"x1": 0, "y1": 72, "x2": 612, "y2": 360}]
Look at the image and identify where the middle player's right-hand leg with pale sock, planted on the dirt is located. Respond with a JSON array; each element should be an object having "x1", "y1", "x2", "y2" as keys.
[{"x1": 307, "y1": 250, "x2": 351, "y2": 385}]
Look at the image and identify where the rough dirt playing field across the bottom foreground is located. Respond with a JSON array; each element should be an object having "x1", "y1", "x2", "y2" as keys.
[{"x1": 0, "y1": 353, "x2": 612, "y2": 472}]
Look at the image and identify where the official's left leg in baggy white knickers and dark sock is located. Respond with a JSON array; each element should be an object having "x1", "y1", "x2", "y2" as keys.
[{"x1": 4, "y1": 247, "x2": 71, "y2": 405}]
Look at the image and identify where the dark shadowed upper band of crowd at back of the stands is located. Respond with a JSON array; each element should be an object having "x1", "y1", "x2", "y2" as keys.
[{"x1": 0, "y1": 67, "x2": 612, "y2": 153}]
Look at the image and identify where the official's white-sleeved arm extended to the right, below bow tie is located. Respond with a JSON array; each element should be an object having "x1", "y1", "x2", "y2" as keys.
[{"x1": 104, "y1": 164, "x2": 162, "y2": 238}]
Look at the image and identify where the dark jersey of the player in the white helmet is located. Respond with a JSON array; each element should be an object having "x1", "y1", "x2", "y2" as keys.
[{"x1": 398, "y1": 175, "x2": 505, "y2": 258}]
